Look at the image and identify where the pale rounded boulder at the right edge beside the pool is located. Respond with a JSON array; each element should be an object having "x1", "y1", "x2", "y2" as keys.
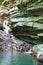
[{"x1": 32, "y1": 44, "x2": 43, "y2": 61}]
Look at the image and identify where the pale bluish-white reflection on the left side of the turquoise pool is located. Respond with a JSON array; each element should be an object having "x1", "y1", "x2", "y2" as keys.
[{"x1": 0, "y1": 52, "x2": 11, "y2": 65}]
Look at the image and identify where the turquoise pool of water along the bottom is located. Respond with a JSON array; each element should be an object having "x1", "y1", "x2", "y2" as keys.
[{"x1": 0, "y1": 51, "x2": 41, "y2": 65}]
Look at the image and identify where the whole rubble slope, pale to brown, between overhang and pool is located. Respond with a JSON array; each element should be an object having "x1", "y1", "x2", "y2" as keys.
[{"x1": 0, "y1": 30, "x2": 32, "y2": 52}]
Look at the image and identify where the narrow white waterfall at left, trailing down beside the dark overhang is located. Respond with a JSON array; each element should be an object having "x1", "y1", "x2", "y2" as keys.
[{"x1": 3, "y1": 20, "x2": 17, "y2": 43}]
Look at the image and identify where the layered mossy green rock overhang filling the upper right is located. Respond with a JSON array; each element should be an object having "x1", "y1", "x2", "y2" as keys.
[{"x1": 0, "y1": 0, "x2": 43, "y2": 42}]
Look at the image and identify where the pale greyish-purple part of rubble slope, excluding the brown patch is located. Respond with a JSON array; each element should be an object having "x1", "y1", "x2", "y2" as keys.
[{"x1": 0, "y1": 30, "x2": 28, "y2": 50}]
